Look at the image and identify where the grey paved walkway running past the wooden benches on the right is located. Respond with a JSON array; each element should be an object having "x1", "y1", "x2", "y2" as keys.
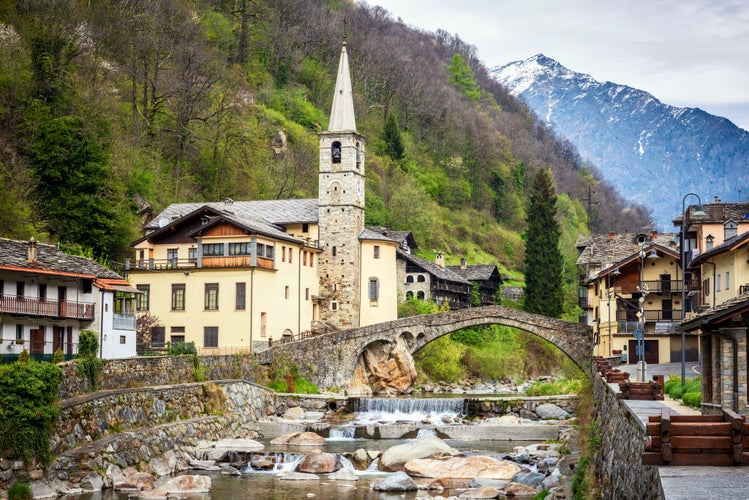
[{"x1": 611, "y1": 363, "x2": 749, "y2": 500}]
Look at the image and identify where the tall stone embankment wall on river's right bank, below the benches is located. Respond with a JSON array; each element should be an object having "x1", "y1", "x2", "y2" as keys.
[{"x1": 593, "y1": 374, "x2": 663, "y2": 499}]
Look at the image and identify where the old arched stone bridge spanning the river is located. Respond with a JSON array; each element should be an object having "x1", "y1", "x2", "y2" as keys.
[{"x1": 257, "y1": 306, "x2": 593, "y2": 390}]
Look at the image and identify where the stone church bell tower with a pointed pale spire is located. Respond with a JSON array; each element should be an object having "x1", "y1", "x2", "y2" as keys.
[{"x1": 318, "y1": 42, "x2": 366, "y2": 329}]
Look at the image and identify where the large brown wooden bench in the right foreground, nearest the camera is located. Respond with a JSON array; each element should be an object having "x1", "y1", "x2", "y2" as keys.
[{"x1": 642, "y1": 408, "x2": 749, "y2": 466}]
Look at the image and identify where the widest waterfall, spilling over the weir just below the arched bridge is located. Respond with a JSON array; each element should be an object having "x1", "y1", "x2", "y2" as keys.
[{"x1": 356, "y1": 398, "x2": 463, "y2": 424}]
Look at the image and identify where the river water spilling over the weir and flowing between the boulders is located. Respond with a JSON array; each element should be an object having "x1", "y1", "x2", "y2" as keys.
[{"x1": 83, "y1": 398, "x2": 548, "y2": 500}]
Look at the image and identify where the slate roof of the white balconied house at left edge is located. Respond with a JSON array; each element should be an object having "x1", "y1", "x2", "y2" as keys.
[{"x1": 0, "y1": 238, "x2": 123, "y2": 280}]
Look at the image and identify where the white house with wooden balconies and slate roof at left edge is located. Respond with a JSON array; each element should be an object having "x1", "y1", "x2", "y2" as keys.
[{"x1": 0, "y1": 238, "x2": 137, "y2": 360}]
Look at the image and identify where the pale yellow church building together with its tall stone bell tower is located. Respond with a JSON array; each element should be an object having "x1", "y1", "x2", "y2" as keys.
[{"x1": 126, "y1": 45, "x2": 398, "y2": 353}]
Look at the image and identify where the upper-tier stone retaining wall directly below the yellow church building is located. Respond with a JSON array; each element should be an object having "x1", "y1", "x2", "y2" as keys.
[{"x1": 60, "y1": 354, "x2": 260, "y2": 399}]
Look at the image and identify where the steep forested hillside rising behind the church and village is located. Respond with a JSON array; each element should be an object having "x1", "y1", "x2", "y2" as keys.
[{"x1": 0, "y1": 0, "x2": 649, "y2": 278}]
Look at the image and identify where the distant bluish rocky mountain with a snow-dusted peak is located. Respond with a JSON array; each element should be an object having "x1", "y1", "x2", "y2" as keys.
[{"x1": 491, "y1": 54, "x2": 749, "y2": 231}]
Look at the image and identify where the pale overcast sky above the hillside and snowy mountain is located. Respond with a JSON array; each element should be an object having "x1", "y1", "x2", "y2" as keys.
[{"x1": 368, "y1": 0, "x2": 749, "y2": 130}]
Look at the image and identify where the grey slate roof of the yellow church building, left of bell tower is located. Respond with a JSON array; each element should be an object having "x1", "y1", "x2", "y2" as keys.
[{"x1": 145, "y1": 198, "x2": 318, "y2": 230}]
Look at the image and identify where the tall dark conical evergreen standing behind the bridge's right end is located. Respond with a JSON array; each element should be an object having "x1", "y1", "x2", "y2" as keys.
[{"x1": 523, "y1": 168, "x2": 564, "y2": 318}]
